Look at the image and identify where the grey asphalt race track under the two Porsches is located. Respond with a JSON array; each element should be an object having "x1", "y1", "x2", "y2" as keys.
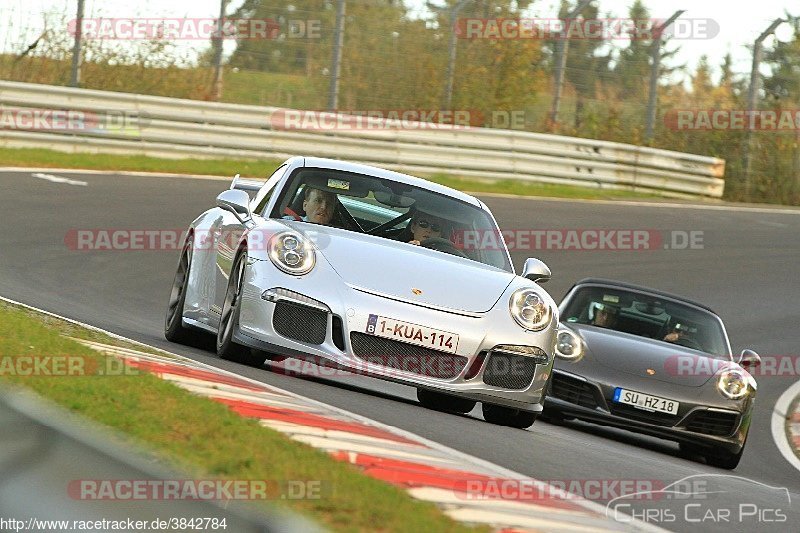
[{"x1": 0, "y1": 171, "x2": 800, "y2": 531}]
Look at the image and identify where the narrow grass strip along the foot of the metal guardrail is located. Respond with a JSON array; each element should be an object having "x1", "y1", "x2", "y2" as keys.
[{"x1": 0, "y1": 148, "x2": 658, "y2": 199}]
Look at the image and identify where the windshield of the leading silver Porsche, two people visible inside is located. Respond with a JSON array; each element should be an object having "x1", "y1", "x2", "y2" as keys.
[{"x1": 270, "y1": 168, "x2": 513, "y2": 272}]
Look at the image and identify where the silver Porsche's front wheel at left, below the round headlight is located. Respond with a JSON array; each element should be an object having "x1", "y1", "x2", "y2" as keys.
[{"x1": 217, "y1": 249, "x2": 267, "y2": 366}]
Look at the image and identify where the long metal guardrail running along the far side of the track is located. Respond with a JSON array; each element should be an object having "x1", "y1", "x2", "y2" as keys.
[{"x1": 0, "y1": 81, "x2": 725, "y2": 198}]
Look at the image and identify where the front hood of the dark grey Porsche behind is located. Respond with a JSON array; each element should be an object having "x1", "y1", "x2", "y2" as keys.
[{"x1": 569, "y1": 324, "x2": 734, "y2": 387}]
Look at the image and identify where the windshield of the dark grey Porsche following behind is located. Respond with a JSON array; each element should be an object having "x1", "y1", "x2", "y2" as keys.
[{"x1": 562, "y1": 287, "x2": 728, "y2": 357}]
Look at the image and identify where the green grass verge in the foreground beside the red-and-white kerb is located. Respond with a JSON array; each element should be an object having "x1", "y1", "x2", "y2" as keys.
[{"x1": 0, "y1": 302, "x2": 488, "y2": 531}]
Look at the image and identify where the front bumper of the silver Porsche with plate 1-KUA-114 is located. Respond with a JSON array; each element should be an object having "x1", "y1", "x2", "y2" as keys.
[{"x1": 235, "y1": 261, "x2": 556, "y2": 412}]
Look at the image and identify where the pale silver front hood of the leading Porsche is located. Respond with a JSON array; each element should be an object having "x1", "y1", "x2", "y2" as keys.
[{"x1": 285, "y1": 221, "x2": 515, "y2": 313}]
